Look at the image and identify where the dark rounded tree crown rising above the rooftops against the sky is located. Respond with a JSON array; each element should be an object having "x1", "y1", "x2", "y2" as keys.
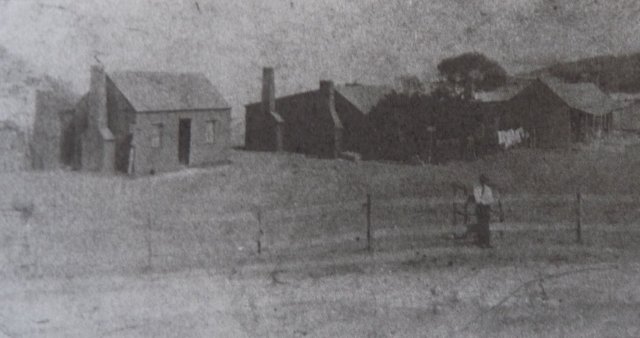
[{"x1": 438, "y1": 52, "x2": 507, "y2": 100}]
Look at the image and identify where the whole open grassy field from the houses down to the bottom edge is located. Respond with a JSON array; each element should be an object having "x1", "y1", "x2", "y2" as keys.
[{"x1": 0, "y1": 150, "x2": 640, "y2": 337}]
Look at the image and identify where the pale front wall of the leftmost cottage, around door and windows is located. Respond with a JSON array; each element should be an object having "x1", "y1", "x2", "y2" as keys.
[{"x1": 132, "y1": 109, "x2": 231, "y2": 175}]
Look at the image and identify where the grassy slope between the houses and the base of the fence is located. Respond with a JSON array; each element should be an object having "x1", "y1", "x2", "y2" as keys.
[{"x1": 0, "y1": 150, "x2": 640, "y2": 275}]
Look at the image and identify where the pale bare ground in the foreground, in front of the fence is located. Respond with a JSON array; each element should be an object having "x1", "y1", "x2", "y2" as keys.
[{"x1": 0, "y1": 224, "x2": 640, "y2": 337}]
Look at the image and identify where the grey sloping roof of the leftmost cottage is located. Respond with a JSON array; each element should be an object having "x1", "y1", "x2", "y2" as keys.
[{"x1": 108, "y1": 71, "x2": 230, "y2": 112}]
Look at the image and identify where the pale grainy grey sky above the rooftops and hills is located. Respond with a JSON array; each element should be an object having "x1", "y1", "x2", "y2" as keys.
[{"x1": 0, "y1": 0, "x2": 640, "y2": 128}]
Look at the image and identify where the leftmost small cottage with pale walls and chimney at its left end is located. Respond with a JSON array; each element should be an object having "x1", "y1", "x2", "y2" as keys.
[{"x1": 72, "y1": 66, "x2": 231, "y2": 174}]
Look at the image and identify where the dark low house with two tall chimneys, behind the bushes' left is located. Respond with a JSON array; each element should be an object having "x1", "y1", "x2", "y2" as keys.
[{"x1": 245, "y1": 68, "x2": 391, "y2": 158}]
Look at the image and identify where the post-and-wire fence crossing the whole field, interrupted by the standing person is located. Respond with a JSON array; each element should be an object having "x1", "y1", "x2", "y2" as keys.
[{"x1": 0, "y1": 186, "x2": 640, "y2": 277}]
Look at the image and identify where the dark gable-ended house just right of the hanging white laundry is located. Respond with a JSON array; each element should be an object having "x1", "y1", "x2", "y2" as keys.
[{"x1": 509, "y1": 78, "x2": 619, "y2": 148}]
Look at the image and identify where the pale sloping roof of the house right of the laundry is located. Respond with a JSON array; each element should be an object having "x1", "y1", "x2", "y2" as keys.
[{"x1": 540, "y1": 77, "x2": 623, "y2": 115}]
